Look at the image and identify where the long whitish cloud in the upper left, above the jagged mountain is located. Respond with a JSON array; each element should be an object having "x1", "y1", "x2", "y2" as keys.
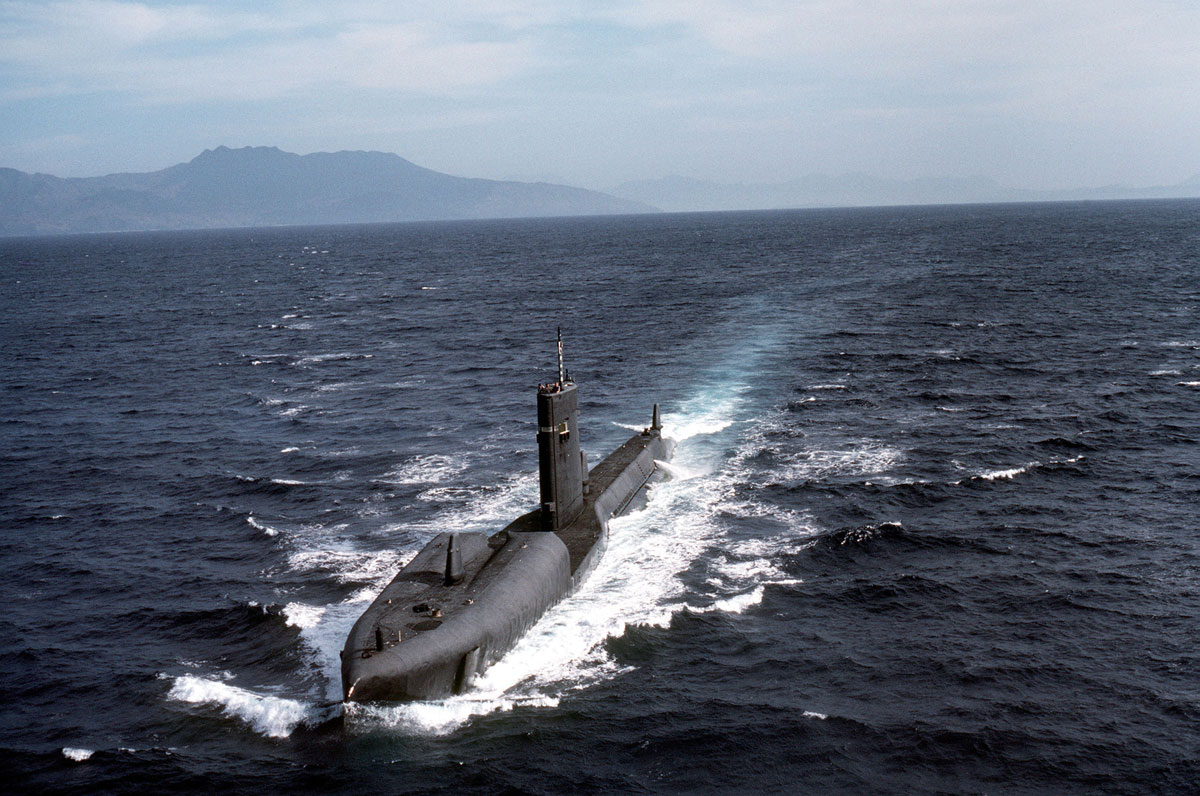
[{"x1": 0, "y1": 0, "x2": 535, "y2": 103}]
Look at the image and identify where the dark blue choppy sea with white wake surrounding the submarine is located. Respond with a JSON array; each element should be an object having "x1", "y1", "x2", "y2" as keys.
[{"x1": 0, "y1": 201, "x2": 1200, "y2": 796}]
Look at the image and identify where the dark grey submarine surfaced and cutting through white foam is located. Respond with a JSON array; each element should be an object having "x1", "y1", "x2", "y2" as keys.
[{"x1": 341, "y1": 333, "x2": 674, "y2": 702}]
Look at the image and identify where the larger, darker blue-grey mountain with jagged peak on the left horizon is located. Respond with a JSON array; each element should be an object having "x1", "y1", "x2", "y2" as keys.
[{"x1": 0, "y1": 146, "x2": 655, "y2": 235}]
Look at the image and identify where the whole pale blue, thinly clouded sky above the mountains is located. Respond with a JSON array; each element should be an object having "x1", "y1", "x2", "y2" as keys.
[{"x1": 0, "y1": 0, "x2": 1200, "y2": 190}]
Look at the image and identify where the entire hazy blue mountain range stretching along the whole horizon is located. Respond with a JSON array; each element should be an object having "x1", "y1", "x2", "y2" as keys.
[{"x1": 0, "y1": 146, "x2": 1200, "y2": 235}]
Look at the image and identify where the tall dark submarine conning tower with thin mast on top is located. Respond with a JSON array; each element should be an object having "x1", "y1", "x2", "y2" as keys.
[{"x1": 538, "y1": 331, "x2": 588, "y2": 531}]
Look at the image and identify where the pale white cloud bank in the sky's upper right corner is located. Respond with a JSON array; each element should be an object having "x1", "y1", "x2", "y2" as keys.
[{"x1": 610, "y1": 0, "x2": 1200, "y2": 102}]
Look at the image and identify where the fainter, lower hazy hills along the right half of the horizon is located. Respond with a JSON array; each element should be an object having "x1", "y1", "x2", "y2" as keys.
[{"x1": 611, "y1": 174, "x2": 1200, "y2": 211}]
